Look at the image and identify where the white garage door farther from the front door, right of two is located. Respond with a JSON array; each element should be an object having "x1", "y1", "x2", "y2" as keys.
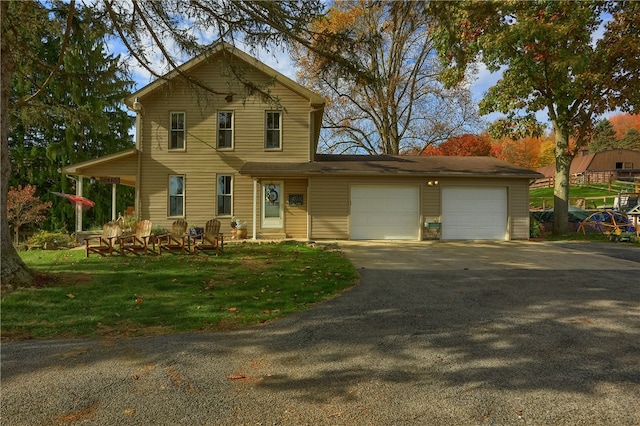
[{"x1": 442, "y1": 187, "x2": 507, "y2": 240}]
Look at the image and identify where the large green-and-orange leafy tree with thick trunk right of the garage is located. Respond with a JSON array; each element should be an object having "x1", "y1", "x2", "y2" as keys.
[{"x1": 428, "y1": 1, "x2": 640, "y2": 235}]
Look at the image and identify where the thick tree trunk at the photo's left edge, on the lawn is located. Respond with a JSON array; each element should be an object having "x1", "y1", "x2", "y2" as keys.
[{"x1": 0, "y1": 1, "x2": 33, "y2": 288}]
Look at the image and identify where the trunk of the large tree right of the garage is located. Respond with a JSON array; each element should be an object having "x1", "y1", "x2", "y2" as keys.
[{"x1": 553, "y1": 123, "x2": 573, "y2": 235}]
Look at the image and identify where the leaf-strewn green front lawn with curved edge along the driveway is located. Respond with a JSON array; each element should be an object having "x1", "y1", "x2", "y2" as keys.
[{"x1": 1, "y1": 242, "x2": 358, "y2": 340}]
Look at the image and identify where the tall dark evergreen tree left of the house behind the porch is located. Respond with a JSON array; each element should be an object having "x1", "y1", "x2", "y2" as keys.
[{"x1": 9, "y1": 3, "x2": 133, "y2": 230}]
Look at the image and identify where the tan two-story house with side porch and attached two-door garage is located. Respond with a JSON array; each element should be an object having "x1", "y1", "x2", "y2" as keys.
[{"x1": 62, "y1": 43, "x2": 540, "y2": 240}]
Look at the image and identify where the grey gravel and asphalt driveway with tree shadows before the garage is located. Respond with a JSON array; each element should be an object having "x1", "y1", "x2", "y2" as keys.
[{"x1": 1, "y1": 242, "x2": 640, "y2": 425}]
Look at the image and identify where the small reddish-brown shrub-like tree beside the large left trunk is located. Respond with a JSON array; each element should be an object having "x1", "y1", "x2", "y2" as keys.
[{"x1": 7, "y1": 184, "x2": 52, "y2": 244}]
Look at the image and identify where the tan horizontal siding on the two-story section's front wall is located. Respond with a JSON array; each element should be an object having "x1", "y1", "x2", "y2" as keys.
[{"x1": 138, "y1": 55, "x2": 311, "y2": 236}]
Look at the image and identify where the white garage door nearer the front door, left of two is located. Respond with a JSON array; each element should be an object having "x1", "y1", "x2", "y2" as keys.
[{"x1": 350, "y1": 185, "x2": 420, "y2": 240}]
